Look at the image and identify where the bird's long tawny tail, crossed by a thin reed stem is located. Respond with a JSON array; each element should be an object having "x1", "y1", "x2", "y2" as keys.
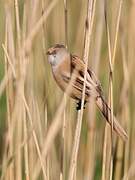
[{"x1": 96, "y1": 97, "x2": 128, "y2": 141}]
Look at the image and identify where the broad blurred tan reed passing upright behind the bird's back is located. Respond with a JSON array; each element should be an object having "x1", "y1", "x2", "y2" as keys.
[{"x1": 84, "y1": 2, "x2": 104, "y2": 180}]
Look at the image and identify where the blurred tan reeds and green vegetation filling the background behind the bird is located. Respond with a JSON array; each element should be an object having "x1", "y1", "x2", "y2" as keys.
[{"x1": 0, "y1": 0, "x2": 135, "y2": 180}]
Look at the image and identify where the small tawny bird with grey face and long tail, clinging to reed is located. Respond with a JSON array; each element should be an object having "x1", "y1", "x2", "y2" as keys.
[{"x1": 46, "y1": 44, "x2": 128, "y2": 141}]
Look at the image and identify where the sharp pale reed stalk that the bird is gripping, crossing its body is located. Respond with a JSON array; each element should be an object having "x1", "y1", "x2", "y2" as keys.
[{"x1": 68, "y1": 0, "x2": 96, "y2": 180}]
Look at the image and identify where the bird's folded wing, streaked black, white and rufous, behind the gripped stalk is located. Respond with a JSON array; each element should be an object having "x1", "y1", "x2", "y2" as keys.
[{"x1": 71, "y1": 55, "x2": 103, "y2": 95}]
